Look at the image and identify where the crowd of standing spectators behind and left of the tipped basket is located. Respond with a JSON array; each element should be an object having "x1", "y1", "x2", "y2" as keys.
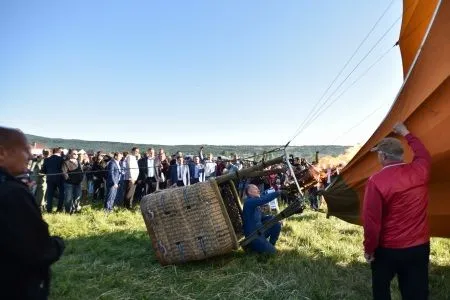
[{"x1": 28, "y1": 147, "x2": 260, "y2": 214}]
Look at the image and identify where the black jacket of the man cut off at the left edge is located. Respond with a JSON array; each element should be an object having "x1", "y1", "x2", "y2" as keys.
[{"x1": 0, "y1": 169, "x2": 64, "y2": 299}]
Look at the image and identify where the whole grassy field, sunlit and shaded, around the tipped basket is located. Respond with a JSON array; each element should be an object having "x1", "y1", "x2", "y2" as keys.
[{"x1": 45, "y1": 206, "x2": 450, "y2": 299}]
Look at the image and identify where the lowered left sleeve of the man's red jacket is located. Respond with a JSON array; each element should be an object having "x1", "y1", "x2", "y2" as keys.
[{"x1": 363, "y1": 179, "x2": 383, "y2": 254}]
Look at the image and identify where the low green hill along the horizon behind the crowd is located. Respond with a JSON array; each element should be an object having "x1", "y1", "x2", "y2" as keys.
[{"x1": 26, "y1": 134, "x2": 349, "y2": 161}]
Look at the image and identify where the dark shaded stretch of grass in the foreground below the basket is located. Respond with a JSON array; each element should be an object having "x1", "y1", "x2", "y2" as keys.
[{"x1": 50, "y1": 231, "x2": 450, "y2": 299}]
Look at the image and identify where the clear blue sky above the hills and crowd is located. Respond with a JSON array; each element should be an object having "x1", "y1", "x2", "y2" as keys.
[{"x1": 0, "y1": 0, "x2": 402, "y2": 145}]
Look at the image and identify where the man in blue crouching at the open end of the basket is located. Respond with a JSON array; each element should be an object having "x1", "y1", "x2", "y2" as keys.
[{"x1": 242, "y1": 184, "x2": 281, "y2": 254}]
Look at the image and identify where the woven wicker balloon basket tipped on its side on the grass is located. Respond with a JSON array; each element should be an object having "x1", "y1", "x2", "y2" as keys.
[{"x1": 141, "y1": 180, "x2": 238, "y2": 265}]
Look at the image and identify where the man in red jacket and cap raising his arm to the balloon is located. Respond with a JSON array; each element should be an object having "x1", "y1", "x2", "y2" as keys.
[{"x1": 363, "y1": 123, "x2": 431, "y2": 299}]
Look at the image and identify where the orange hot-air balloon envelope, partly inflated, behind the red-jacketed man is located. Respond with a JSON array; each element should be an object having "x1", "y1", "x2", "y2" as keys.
[{"x1": 324, "y1": 0, "x2": 450, "y2": 237}]
